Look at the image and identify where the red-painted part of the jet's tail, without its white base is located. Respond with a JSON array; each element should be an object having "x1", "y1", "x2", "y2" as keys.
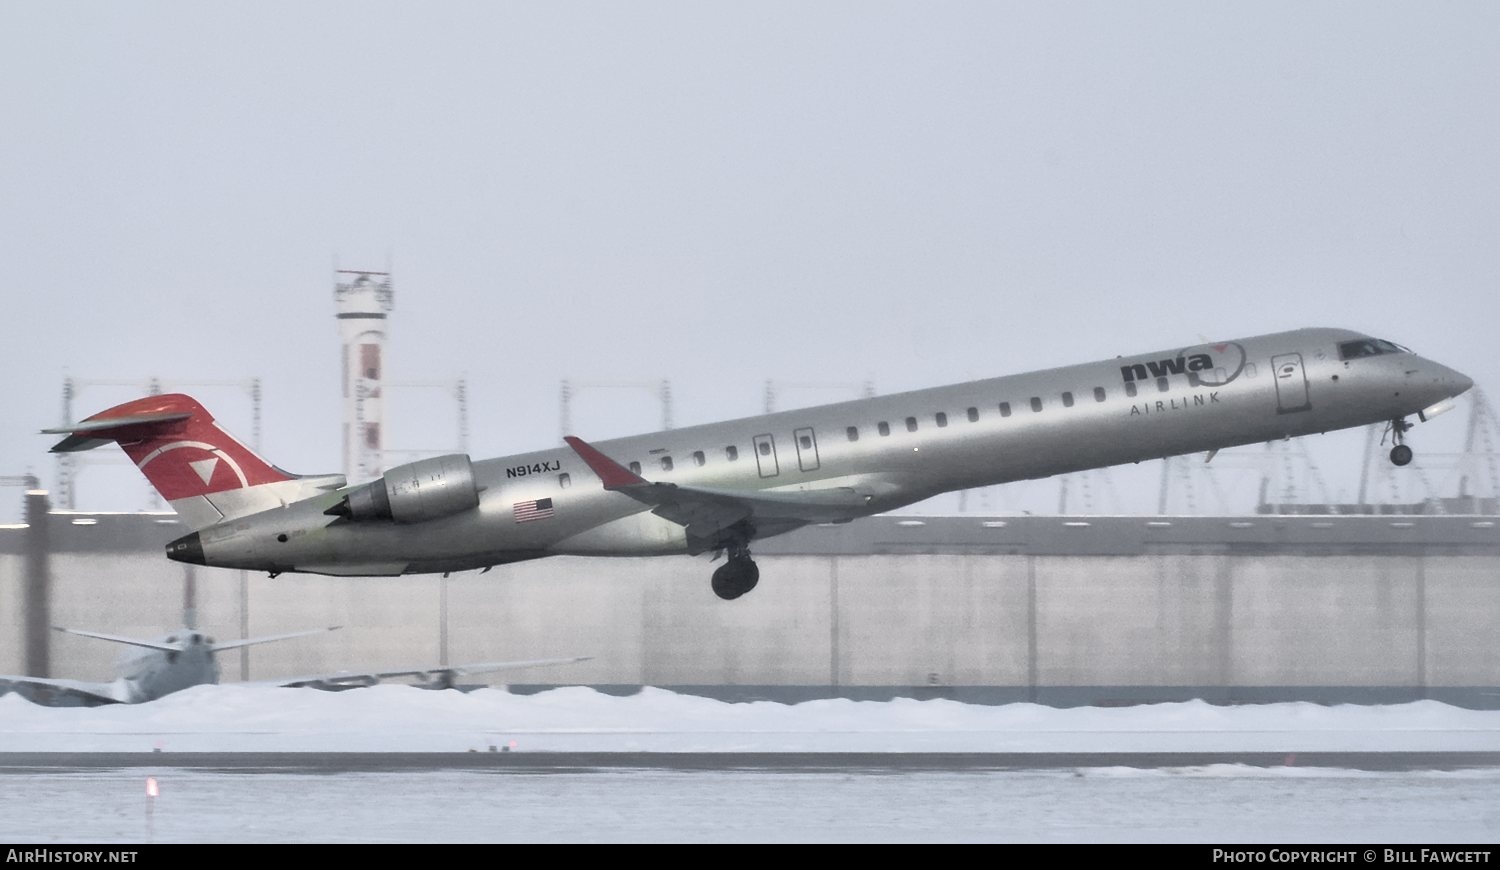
[{"x1": 44, "y1": 393, "x2": 293, "y2": 503}]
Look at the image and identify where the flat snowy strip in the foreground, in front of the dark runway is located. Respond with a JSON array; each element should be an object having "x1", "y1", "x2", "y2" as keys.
[{"x1": 0, "y1": 765, "x2": 1500, "y2": 845}]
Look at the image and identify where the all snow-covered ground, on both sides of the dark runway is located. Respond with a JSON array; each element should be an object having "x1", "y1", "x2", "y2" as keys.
[{"x1": 0, "y1": 686, "x2": 1500, "y2": 845}]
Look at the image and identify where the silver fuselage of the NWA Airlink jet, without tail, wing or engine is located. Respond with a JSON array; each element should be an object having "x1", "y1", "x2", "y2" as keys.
[{"x1": 168, "y1": 329, "x2": 1470, "y2": 576}]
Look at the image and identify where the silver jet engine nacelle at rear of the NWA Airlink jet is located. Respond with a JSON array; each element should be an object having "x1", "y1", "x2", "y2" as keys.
[{"x1": 324, "y1": 453, "x2": 479, "y2": 522}]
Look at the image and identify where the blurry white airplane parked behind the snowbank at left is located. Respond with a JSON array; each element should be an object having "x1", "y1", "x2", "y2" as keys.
[{"x1": 0, "y1": 626, "x2": 587, "y2": 707}]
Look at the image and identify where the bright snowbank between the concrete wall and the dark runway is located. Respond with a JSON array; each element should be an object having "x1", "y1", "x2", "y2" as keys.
[{"x1": 0, "y1": 684, "x2": 1500, "y2": 753}]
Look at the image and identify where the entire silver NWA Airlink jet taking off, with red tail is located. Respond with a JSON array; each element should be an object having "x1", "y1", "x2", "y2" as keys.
[{"x1": 47, "y1": 329, "x2": 1473, "y2": 599}]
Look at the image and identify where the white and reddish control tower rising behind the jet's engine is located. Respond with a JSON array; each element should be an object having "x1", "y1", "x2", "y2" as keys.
[{"x1": 333, "y1": 269, "x2": 396, "y2": 483}]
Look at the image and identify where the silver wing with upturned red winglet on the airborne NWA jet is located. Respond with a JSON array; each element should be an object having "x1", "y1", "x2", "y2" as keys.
[{"x1": 563, "y1": 435, "x2": 872, "y2": 552}]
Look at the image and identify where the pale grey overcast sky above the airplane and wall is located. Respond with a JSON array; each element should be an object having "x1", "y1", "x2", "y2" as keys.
[{"x1": 0, "y1": 0, "x2": 1500, "y2": 519}]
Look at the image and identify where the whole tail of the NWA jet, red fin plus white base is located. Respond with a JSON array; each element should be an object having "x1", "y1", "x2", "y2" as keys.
[{"x1": 42, "y1": 393, "x2": 344, "y2": 530}]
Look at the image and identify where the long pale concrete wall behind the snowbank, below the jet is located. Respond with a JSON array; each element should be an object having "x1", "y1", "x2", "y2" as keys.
[{"x1": 0, "y1": 513, "x2": 1500, "y2": 707}]
